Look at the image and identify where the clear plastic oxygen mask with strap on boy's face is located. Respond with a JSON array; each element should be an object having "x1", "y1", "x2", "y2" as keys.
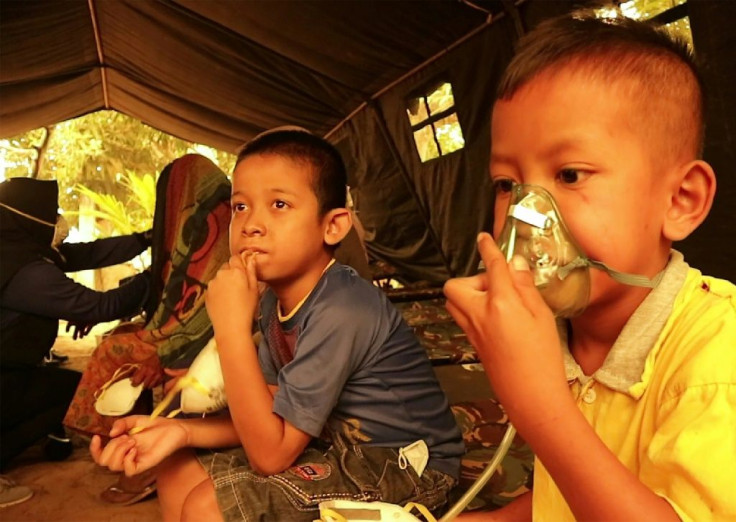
[{"x1": 497, "y1": 184, "x2": 662, "y2": 318}]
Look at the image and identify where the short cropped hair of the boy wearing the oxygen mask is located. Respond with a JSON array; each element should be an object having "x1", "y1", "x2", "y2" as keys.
[{"x1": 496, "y1": 9, "x2": 704, "y2": 157}]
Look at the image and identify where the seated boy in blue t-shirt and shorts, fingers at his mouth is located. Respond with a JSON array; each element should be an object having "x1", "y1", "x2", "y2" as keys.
[{"x1": 91, "y1": 128, "x2": 463, "y2": 522}]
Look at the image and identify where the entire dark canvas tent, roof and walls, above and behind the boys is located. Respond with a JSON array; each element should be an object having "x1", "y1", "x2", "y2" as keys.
[{"x1": 0, "y1": 0, "x2": 736, "y2": 284}]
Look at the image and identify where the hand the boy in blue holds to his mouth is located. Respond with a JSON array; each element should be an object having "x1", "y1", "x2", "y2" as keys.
[{"x1": 205, "y1": 253, "x2": 258, "y2": 339}]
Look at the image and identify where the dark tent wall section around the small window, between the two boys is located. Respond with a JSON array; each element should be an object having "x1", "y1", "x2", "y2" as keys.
[{"x1": 334, "y1": 1, "x2": 572, "y2": 284}]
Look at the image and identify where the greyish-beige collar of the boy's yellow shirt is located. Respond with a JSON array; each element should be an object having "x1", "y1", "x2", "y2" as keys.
[{"x1": 558, "y1": 250, "x2": 689, "y2": 398}]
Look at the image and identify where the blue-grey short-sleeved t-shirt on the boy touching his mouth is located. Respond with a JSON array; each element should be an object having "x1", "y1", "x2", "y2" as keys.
[{"x1": 258, "y1": 263, "x2": 464, "y2": 478}]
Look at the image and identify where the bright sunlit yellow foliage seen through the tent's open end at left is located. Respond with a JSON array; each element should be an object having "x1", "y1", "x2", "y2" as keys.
[{"x1": 0, "y1": 111, "x2": 235, "y2": 236}]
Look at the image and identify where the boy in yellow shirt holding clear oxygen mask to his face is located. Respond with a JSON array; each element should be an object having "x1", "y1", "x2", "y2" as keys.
[{"x1": 445, "y1": 8, "x2": 736, "y2": 521}]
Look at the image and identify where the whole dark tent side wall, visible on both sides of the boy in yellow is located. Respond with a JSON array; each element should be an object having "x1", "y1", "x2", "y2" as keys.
[{"x1": 335, "y1": 0, "x2": 736, "y2": 283}]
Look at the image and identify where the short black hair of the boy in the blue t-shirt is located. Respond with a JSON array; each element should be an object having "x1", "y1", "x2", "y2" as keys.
[{"x1": 235, "y1": 127, "x2": 347, "y2": 217}]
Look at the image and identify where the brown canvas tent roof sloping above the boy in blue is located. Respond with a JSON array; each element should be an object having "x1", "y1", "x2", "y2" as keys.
[{"x1": 0, "y1": 0, "x2": 502, "y2": 151}]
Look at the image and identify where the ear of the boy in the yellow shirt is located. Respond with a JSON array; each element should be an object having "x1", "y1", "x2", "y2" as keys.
[{"x1": 663, "y1": 160, "x2": 716, "y2": 241}]
